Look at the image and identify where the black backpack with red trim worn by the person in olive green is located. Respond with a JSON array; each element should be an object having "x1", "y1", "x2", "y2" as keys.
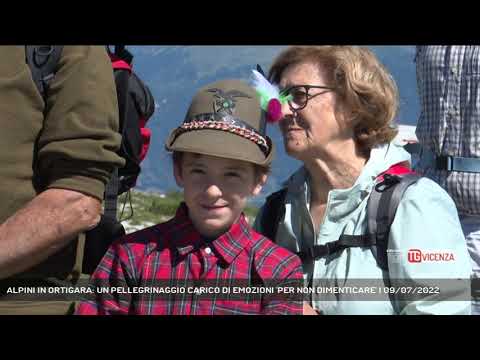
[{"x1": 25, "y1": 45, "x2": 155, "y2": 274}]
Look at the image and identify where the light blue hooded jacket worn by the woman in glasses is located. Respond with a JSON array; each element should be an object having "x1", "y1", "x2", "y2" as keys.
[{"x1": 254, "y1": 144, "x2": 471, "y2": 314}]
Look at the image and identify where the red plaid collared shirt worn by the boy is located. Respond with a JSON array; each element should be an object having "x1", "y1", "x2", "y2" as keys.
[{"x1": 76, "y1": 203, "x2": 303, "y2": 315}]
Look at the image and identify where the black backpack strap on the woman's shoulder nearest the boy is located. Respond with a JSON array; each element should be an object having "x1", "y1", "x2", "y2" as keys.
[{"x1": 260, "y1": 188, "x2": 287, "y2": 242}]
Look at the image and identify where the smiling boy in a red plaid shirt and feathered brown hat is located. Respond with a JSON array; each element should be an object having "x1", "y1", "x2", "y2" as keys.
[{"x1": 77, "y1": 80, "x2": 303, "y2": 315}]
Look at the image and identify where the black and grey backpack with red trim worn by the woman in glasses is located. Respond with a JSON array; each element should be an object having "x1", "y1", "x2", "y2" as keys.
[{"x1": 260, "y1": 164, "x2": 420, "y2": 270}]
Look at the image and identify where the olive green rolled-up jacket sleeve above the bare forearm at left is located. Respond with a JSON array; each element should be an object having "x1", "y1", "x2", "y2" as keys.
[{"x1": 36, "y1": 46, "x2": 124, "y2": 199}]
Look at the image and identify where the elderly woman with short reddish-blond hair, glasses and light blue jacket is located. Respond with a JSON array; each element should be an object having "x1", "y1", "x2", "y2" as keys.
[{"x1": 255, "y1": 46, "x2": 471, "y2": 314}]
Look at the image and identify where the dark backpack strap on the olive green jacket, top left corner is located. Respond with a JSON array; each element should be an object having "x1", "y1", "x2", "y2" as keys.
[{"x1": 25, "y1": 45, "x2": 63, "y2": 101}]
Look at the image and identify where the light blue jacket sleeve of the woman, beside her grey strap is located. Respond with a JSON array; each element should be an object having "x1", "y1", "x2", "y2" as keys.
[{"x1": 388, "y1": 178, "x2": 471, "y2": 314}]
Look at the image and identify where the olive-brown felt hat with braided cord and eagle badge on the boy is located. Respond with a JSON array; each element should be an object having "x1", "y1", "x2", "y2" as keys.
[{"x1": 165, "y1": 80, "x2": 275, "y2": 165}]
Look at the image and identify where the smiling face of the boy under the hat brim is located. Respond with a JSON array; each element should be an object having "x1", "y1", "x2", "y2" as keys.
[{"x1": 174, "y1": 152, "x2": 267, "y2": 237}]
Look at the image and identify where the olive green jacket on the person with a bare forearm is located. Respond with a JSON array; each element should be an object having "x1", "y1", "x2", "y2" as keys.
[{"x1": 0, "y1": 46, "x2": 124, "y2": 312}]
